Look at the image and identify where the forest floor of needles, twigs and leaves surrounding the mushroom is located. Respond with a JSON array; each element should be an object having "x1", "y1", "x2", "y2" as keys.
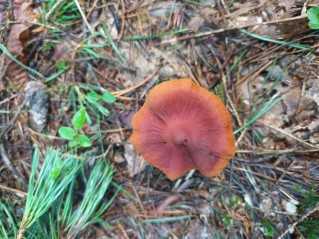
[{"x1": 0, "y1": 0, "x2": 319, "y2": 239}]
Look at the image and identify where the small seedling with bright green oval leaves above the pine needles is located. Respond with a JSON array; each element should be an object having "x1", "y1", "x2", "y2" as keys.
[{"x1": 59, "y1": 108, "x2": 92, "y2": 148}]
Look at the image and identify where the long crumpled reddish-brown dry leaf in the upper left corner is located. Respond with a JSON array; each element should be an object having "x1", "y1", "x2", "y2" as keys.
[{"x1": 6, "y1": 1, "x2": 38, "y2": 90}]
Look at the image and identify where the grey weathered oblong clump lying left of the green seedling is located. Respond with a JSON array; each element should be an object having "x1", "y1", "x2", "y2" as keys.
[{"x1": 24, "y1": 81, "x2": 49, "y2": 132}]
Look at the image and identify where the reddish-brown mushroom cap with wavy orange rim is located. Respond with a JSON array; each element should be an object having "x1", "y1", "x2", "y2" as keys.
[{"x1": 131, "y1": 79, "x2": 235, "y2": 180}]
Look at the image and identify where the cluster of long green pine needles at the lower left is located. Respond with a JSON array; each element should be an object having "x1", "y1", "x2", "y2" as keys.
[{"x1": 0, "y1": 149, "x2": 115, "y2": 239}]
